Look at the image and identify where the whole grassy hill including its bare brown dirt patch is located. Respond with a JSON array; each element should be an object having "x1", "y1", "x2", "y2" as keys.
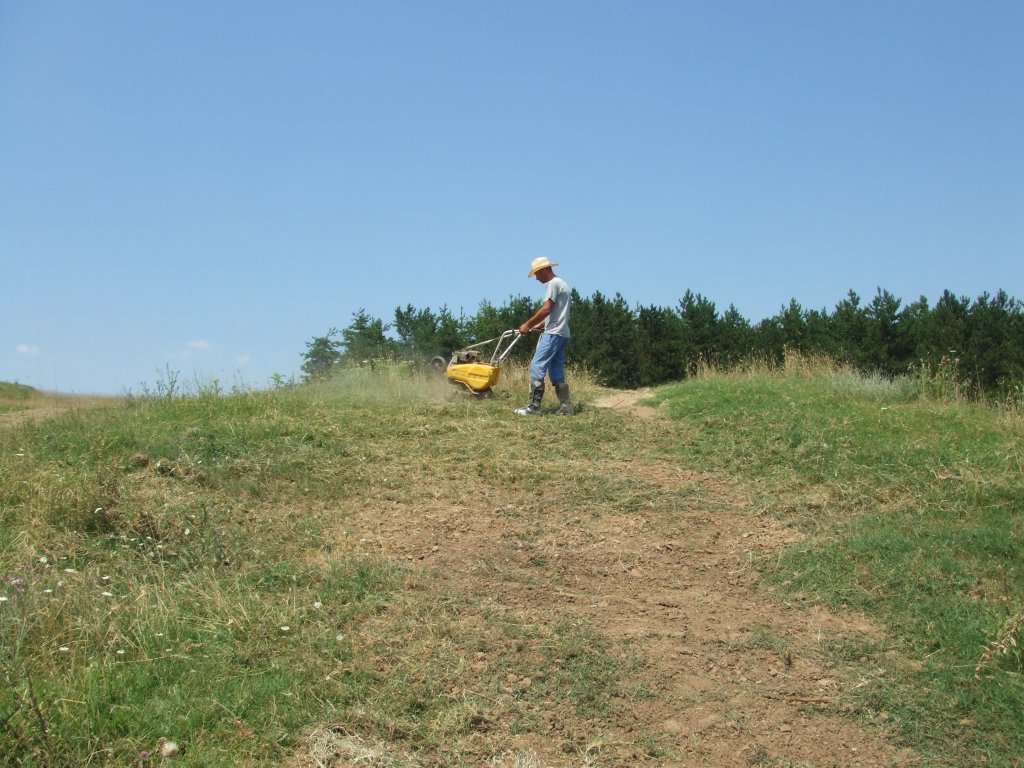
[{"x1": 0, "y1": 368, "x2": 1024, "y2": 768}]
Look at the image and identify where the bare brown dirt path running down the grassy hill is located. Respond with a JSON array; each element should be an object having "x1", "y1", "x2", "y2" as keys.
[{"x1": 332, "y1": 393, "x2": 918, "y2": 768}]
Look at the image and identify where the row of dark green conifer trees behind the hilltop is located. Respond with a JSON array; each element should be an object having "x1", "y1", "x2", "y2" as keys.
[{"x1": 302, "y1": 289, "x2": 1024, "y2": 392}]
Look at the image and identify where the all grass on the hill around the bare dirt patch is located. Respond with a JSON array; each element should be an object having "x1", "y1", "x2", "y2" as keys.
[{"x1": 0, "y1": 366, "x2": 1024, "y2": 767}]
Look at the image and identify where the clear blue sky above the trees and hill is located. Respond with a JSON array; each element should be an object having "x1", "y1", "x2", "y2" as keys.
[{"x1": 0, "y1": 0, "x2": 1024, "y2": 394}]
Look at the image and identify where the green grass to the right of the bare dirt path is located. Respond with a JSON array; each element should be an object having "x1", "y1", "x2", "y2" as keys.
[{"x1": 657, "y1": 366, "x2": 1024, "y2": 765}]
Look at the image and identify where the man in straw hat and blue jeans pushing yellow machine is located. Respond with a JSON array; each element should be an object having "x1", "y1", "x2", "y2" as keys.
[{"x1": 515, "y1": 256, "x2": 572, "y2": 416}]
